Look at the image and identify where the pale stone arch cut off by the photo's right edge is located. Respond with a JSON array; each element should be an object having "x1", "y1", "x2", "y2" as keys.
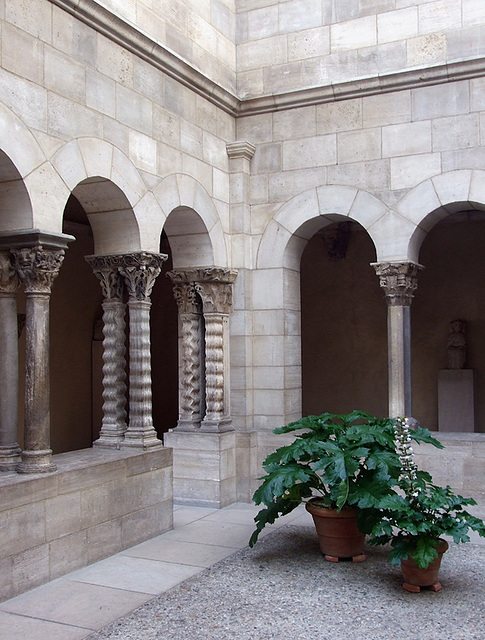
[{"x1": 396, "y1": 169, "x2": 485, "y2": 262}]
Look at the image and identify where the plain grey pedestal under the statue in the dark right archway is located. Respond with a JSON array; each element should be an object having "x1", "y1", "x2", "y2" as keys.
[{"x1": 438, "y1": 369, "x2": 475, "y2": 432}]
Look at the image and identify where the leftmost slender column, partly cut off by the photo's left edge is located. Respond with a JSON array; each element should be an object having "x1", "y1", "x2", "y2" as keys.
[{"x1": 0, "y1": 251, "x2": 20, "y2": 471}]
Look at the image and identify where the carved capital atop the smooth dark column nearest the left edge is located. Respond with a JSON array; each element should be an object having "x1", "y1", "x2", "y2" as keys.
[{"x1": 12, "y1": 244, "x2": 64, "y2": 294}]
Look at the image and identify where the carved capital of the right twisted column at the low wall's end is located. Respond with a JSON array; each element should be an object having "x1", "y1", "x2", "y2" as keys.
[{"x1": 118, "y1": 252, "x2": 168, "y2": 302}]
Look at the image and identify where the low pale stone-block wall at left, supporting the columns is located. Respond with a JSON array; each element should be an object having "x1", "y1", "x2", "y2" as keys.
[{"x1": 0, "y1": 449, "x2": 172, "y2": 600}]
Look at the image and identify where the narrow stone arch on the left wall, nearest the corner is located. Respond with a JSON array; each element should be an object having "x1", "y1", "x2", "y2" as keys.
[{"x1": 154, "y1": 174, "x2": 228, "y2": 268}]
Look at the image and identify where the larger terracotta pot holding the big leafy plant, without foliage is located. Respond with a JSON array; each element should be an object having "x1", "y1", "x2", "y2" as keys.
[{"x1": 306, "y1": 500, "x2": 365, "y2": 562}]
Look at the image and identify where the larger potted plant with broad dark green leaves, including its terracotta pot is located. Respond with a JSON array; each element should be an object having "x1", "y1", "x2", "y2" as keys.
[{"x1": 249, "y1": 411, "x2": 441, "y2": 561}]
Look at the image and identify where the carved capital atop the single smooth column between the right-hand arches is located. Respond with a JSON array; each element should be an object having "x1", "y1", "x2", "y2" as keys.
[{"x1": 372, "y1": 262, "x2": 423, "y2": 307}]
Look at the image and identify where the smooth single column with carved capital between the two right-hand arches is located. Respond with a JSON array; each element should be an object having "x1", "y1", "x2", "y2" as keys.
[{"x1": 372, "y1": 262, "x2": 423, "y2": 417}]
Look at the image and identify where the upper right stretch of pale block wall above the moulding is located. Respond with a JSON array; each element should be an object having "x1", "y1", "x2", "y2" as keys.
[{"x1": 236, "y1": 0, "x2": 485, "y2": 97}]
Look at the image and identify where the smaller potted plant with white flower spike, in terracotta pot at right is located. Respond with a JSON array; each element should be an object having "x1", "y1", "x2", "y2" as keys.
[{"x1": 360, "y1": 418, "x2": 485, "y2": 592}]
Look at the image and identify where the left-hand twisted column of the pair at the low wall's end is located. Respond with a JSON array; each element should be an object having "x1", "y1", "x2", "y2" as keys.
[{"x1": 86, "y1": 256, "x2": 127, "y2": 448}]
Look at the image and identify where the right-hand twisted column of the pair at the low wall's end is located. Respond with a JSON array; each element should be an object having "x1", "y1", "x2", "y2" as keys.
[{"x1": 119, "y1": 252, "x2": 168, "y2": 449}]
